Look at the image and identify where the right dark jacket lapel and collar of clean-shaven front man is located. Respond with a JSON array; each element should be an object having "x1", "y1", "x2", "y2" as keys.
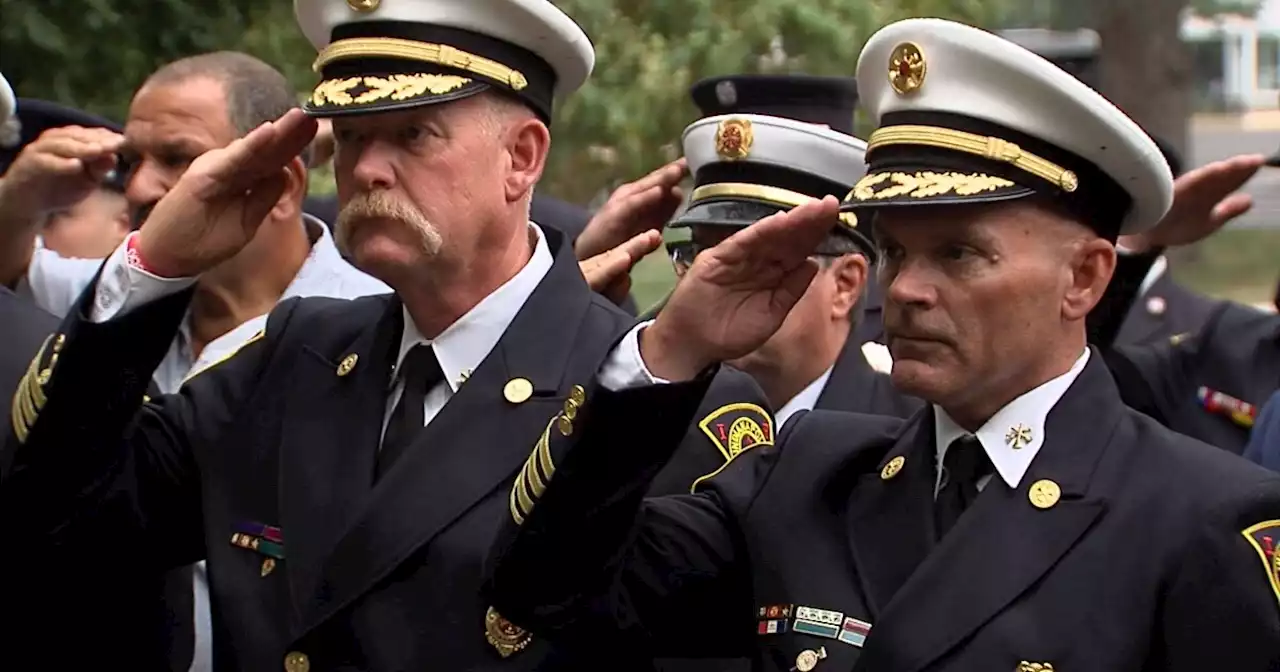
[{"x1": 858, "y1": 352, "x2": 1124, "y2": 672}]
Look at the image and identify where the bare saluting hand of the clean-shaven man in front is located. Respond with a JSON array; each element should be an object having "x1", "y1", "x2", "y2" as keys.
[{"x1": 640, "y1": 196, "x2": 840, "y2": 380}]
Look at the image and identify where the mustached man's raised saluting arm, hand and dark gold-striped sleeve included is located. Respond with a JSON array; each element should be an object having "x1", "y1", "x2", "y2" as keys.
[{"x1": 0, "y1": 109, "x2": 316, "y2": 567}]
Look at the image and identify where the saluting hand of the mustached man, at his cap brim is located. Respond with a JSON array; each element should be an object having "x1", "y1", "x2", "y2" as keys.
[{"x1": 137, "y1": 109, "x2": 316, "y2": 278}]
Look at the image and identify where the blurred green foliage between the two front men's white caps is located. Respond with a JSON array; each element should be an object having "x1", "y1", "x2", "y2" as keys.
[{"x1": 544, "y1": 0, "x2": 1020, "y2": 202}]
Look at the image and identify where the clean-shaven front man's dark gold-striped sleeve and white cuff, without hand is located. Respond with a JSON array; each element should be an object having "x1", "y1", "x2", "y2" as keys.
[{"x1": 485, "y1": 322, "x2": 750, "y2": 657}]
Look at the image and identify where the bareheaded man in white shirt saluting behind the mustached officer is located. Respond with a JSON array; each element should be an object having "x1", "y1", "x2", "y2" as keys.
[{"x1": 0, "y1": 51, "x2": 389, "y2": 672}]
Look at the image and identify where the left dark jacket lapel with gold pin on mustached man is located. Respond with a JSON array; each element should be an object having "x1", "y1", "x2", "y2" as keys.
[{"x1": 279, "y1": 297, "x2": 403, "y2": 611}]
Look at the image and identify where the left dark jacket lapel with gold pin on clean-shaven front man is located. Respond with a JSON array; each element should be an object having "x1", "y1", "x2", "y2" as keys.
[{"x1": 847, "y1": 408, "x2": 934, "y2": 616}]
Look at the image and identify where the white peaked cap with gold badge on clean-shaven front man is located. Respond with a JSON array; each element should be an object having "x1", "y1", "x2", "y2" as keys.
[{"x1": 845, "y1": 19, "x2": 1172, "y2": 238}]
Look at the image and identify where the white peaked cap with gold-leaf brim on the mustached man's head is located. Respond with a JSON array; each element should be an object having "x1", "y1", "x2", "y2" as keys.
[{"x1": 293, "y1": 0, "x2": 595, "y2": 119}]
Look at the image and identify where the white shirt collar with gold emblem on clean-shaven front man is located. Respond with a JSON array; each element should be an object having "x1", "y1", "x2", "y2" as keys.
[{"x1": 933, "y1": 348, "x2": 1089, "y2": 497}]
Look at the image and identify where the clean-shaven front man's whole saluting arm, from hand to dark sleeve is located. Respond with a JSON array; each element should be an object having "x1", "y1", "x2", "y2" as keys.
[{"x1": 488, "y1": 196, "x2": 838, "y2": 655}]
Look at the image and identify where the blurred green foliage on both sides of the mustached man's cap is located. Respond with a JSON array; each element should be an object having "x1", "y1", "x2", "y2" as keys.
[{"x1": 0, "y1": 0, "x2": 1023, "y2": 202}]
